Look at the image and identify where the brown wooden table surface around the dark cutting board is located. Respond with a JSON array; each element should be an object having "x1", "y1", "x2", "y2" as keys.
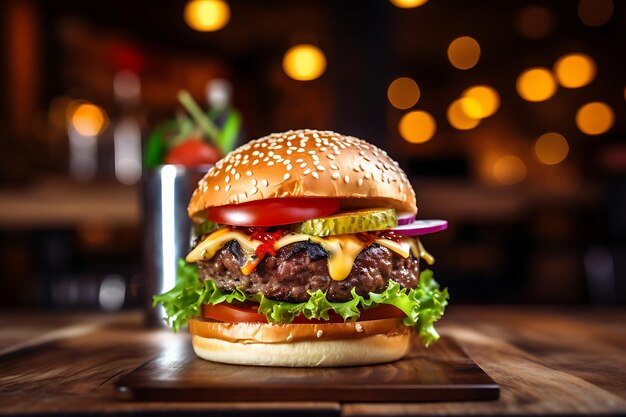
[{"x1": 0, "y1": 305, "x2": 626, "y2": 416}]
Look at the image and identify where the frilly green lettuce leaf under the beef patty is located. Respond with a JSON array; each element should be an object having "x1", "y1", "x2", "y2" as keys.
[{"x1": 153, "y1": 259, "x2": 449, "y2": 345}]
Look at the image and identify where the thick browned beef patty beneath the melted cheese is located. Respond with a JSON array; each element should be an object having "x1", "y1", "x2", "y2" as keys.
[{"x1": 198, "y1": 241, "x2": 419, "y2": 302}]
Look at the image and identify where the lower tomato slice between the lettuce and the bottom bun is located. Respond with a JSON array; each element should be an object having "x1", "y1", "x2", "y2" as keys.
[{"x1": 202, "y1": 303, "x2": 404, "y2": 324}]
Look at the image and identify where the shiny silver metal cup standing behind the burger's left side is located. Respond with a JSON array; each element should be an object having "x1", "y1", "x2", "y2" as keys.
[{"x1": 142, "y1": 165, "x2": 209, "y2": 326}]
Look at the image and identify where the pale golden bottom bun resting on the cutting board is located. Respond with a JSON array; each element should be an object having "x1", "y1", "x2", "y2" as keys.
[{"x1": 190, "y1": 316, "x2": 411, "y2": 367}]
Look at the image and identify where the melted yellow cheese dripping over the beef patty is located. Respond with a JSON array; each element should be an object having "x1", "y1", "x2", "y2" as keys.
[{"x1": 186, "y1": 227, "x2": 435, "y2": 281}]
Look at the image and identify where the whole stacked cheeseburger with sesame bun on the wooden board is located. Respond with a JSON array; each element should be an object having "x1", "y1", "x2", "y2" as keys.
[{"x1": 154, "y1": 130, "x2": 448, "y2": 367}]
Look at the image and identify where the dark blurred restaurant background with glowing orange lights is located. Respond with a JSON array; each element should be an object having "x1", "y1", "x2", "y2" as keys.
[{"x1": 0, "y1": 0, "x2": 626, "y2": 311}]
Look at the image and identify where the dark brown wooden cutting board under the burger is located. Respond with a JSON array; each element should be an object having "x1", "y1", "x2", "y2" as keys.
[{"x1": 115, "y1": 337, "x2": 500, "y2": 402}]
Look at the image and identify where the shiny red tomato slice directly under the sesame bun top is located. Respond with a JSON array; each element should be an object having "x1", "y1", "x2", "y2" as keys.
[{"x1": 207, "y1": 198, "x2": 339, "y2": 226}]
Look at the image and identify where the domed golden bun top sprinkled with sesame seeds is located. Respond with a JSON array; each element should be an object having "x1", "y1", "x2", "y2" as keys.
[{"x1": 188, "y1": 129, "x2": 417, "y2": 218}]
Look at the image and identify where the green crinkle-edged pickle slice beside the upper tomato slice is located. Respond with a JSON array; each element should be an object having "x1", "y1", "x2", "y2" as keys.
[{"x1": 294, "y1": 208, "x2": 398, "y2": 237}]
